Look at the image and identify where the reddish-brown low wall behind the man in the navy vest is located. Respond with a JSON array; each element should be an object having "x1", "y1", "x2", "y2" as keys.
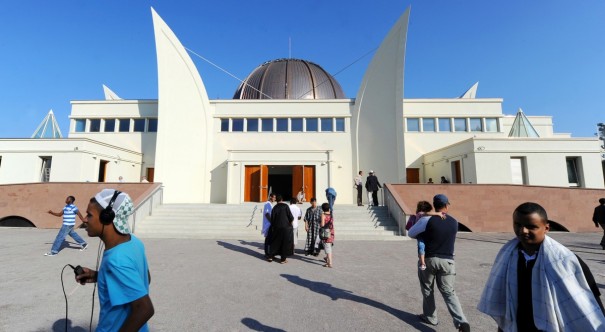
[{"x1": 386, "y1": 184, "x2": 605, "y2": 232}]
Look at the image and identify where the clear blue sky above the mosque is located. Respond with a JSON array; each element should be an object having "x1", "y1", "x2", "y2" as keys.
[{"x1": 0, "y1": 0, "x2": 605, "y2": 138}]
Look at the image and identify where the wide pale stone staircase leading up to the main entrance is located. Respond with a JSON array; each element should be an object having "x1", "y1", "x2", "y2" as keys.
[{"x1": 135, "y1": 203, "x2": 407, "y2": 241}]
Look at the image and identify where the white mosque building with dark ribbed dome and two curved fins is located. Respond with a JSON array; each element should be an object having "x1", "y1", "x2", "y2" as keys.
[{"x1": 0, "y1": 9, "x2": 604, "y2": 204}]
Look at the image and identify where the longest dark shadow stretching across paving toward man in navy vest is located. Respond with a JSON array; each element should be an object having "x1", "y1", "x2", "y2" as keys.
[{"x1": 281, "y1": 274, "x2": 435, "y2": 332}]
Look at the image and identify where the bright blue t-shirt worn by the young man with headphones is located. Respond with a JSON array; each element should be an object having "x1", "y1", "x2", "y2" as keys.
[{"x1": 97, "y1": 234, "x2": 149, "y2": 331}]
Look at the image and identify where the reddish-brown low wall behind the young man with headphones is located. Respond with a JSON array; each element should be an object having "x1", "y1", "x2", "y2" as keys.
[{"x1": 0, "y1": 182, "x2": 162, "y2": 228}]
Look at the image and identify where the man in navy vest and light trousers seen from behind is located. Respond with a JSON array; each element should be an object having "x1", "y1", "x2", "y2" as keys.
[{"x1": 408, "y1": 194, "x2": 470, "y2": 331}]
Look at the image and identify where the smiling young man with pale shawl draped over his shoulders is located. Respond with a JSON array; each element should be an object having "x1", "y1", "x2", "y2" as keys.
[{"x1": 477, "y1": 202, "x2": 605, "y2": 331}]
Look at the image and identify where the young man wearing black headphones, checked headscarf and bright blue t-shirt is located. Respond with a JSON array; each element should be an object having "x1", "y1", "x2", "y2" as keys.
[{"x1": 76, "y1": 189, "x2": 154, "y2": 331}]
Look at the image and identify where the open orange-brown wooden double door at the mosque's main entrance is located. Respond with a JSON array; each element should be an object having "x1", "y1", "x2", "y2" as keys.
[{"x1": 244, "y1": 165, "x2": 315, "y2": 202}]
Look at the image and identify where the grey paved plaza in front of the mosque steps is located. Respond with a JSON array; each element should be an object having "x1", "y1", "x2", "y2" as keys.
[{"x1": 0, "y1": 228, "x2": 605, "y2": 331}]
